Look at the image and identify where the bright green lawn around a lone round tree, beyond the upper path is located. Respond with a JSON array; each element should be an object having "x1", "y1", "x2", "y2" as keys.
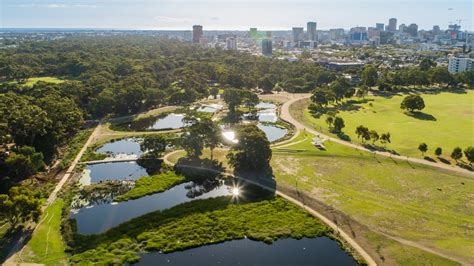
[{"x1": 303, "y1": 91, "x2": 474, "y2": 159}]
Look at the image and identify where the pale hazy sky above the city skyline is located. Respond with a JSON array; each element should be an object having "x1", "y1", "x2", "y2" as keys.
[{"x1": 0, "y1": 0, "x2": 474, "y2": 31}]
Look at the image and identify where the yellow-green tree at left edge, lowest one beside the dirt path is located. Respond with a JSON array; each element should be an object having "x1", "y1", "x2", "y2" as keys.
[{"x1": 0, "y1": 187, "x2": 41, "y2": 228}]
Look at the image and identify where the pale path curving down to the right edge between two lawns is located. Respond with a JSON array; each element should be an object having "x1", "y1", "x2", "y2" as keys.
[{"x1": 280, "y1": 94, "x2": 474, "y2": 177}]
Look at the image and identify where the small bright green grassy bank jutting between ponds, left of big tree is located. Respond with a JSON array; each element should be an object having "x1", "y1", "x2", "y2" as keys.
[{"x1": 114, "y1": 171, "x2": 186, "y2": 201}]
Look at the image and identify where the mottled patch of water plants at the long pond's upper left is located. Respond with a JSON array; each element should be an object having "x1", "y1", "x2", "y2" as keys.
[{"x1": 71, "y1": 181, "x2": 133, "y2": 210}]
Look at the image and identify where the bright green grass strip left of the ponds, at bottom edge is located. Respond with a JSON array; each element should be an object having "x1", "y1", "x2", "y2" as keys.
[{"x1": 21, "y1": 199, "x2": 67, "y2": 265}]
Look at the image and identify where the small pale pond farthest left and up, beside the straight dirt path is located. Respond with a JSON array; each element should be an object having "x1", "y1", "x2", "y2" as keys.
[{"x1": 96, "y1": 138, "x2": 143, "y2": 158}]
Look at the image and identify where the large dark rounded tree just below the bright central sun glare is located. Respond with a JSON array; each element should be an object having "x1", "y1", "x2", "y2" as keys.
[{"x1": 227, "y1": 125, "x2": 272, "y2": 171}]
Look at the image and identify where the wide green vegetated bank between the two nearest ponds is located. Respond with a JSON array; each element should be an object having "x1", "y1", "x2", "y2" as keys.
[{"x1": 72, "y1": 197, "x2": 331, "y2": 264}]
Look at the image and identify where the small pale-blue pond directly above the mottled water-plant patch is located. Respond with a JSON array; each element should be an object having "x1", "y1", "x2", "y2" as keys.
[{"x1": 80, "y1": 162, "x2": 148, "y2": 185}]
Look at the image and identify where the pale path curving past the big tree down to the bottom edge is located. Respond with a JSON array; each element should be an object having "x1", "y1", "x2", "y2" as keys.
[{"x1": 163, "y1": 150, "x2": 377, "y2": 266}]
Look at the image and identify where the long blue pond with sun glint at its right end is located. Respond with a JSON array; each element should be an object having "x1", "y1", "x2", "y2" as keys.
[{"x1": 70, "y1": 180, "x2": 231, "y2": 234}]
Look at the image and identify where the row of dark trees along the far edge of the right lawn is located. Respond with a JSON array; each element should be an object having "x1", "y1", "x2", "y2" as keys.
[{"x1": 360, "y1": 61, "x2": 474, "y2": 91}]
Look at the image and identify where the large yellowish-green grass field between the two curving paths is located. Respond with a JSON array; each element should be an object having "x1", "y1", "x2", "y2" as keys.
[{"x1": 272, "y1": 133, "x2": 474, "y2": 264}]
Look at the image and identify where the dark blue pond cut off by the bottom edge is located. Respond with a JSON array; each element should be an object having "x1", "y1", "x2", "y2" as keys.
[{"x1": 138, "y1": 237, "x2": 356, "y2": 266}]
